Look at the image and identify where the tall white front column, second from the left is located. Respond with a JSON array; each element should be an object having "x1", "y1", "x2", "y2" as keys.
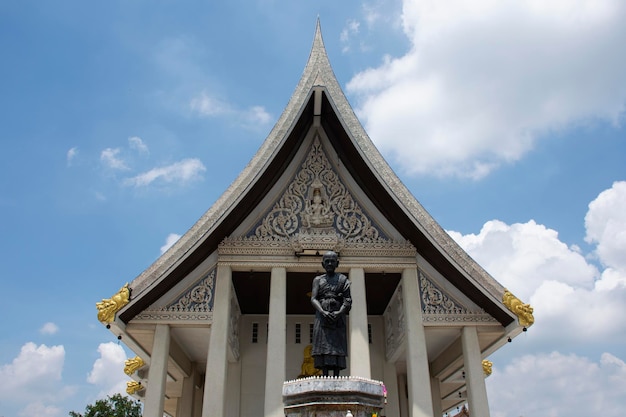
[{"x1": 200, "y1": 265, "x2": 232, "y2": 417}]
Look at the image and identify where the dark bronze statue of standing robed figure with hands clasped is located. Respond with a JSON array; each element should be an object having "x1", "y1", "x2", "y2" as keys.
[{"x1": 311, "y1": 251, "x2": 352, "y2": 376}]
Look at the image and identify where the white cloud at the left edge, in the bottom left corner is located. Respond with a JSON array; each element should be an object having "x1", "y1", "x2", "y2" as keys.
[{"x1": 0, "y1": 342, "x2": 74, "y2": 411}]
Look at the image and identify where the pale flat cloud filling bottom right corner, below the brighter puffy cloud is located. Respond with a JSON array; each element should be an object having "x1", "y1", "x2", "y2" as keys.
[{"x1": 486, "y1": 352, "x2": 626, "y2": 417}]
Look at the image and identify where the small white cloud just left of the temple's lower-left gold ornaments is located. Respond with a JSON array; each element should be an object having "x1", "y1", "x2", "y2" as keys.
[{"x1": 87, "y1": 342, "x2": 128, "y2": 398}]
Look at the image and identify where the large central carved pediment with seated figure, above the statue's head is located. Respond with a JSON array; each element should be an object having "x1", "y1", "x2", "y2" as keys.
[{"x1": 220, "y1": 137, "x2": 415, "y2": 256}]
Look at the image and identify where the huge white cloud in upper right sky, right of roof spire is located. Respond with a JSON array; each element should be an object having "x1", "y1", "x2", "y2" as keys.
[{"x1": 347, "y1": 0, "x2": 626, "y2": 178}]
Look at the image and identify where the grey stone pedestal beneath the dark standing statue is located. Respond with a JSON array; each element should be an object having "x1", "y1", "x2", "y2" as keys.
[{"x1": 283, "y1": 376, "x2": 385, "y2": 417}]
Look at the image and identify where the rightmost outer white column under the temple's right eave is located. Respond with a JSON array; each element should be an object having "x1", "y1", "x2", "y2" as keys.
[{"x1": 461, "y1": 326, "x2": 489, "y2": 417}]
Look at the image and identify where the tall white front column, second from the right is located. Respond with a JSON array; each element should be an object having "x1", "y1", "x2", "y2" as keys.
[{"x1": 402, "y1": 268, "x2": 434, "y2": 417}]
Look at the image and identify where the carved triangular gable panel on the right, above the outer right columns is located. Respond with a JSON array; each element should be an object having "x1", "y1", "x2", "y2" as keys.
[{"x1": 418, "y1": 269, "x2": 497, "y2": 324}]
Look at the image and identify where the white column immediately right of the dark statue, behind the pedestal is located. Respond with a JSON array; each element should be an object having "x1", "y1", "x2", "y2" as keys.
[{"x1": 348, "y1": 268, "x2": 372, "y2": 379}]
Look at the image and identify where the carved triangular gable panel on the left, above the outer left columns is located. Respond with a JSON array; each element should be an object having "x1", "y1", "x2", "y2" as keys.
[{"x1": 136, "y1": 269, "x2": 216, "y2": 321}]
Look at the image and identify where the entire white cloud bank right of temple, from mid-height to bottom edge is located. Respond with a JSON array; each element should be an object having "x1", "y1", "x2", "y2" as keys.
[{"x1": 449, "y1": 182, "x2": 626, "y2": 417}]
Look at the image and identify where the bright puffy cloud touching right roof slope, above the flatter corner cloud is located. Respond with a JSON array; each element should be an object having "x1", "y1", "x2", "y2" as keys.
[{"x1": 449, "y1": 182, "x2": 626, "y2": 349}]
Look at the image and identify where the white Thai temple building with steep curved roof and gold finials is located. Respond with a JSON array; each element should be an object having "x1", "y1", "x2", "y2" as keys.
[{"x1": 97, "y1": 23, "x2": 534, "y2": 417}]
